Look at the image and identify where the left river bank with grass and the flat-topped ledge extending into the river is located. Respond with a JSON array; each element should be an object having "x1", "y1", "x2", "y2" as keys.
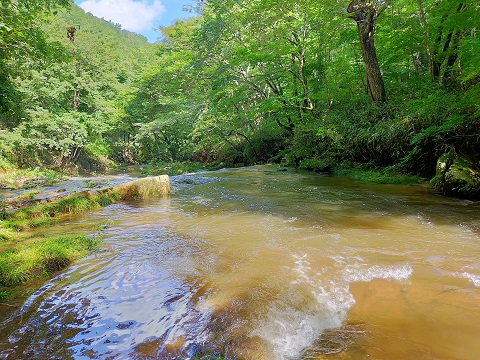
[{"x1": 0, "y1": 175, "x2": 170, "y2": 300}]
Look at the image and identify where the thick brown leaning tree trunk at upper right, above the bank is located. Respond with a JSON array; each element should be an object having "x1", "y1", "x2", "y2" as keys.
[{"x1": 347, "y1": 0, "x2": 387, "y2": 102}]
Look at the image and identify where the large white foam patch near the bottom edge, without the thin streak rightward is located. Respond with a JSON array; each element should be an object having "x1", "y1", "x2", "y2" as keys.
[{"x1": 251, "y1": 254, "x2": 355, "y2": 360}]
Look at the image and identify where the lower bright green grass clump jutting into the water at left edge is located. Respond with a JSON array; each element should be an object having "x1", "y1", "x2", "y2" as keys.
[{"x1": 0, "y1": 235, "x2": 100, "y2": 288}]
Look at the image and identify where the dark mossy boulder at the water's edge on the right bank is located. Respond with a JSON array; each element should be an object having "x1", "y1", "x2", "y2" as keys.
[{"x1": 435, "y1": 152, "x2": 480, "y2": 199}]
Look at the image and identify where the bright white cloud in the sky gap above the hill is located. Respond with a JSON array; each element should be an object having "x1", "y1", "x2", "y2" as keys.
[{"x1": 79, "y1": 0, "x2": 165, "y2": 32}]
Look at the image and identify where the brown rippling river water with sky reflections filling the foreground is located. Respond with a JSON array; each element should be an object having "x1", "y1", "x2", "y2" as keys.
[{"x1": 0, "y1": 167, "x2": 480, "y2": 360}]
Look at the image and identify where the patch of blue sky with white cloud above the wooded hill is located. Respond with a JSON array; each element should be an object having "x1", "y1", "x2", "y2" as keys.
[{"x1": 75, "y1": 0, "x2": 196, "y2": 43}]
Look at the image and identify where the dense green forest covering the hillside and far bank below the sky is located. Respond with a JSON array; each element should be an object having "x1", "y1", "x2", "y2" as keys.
[{"x1": 0, "y1": 0, "x2": 480, "y2": 197}]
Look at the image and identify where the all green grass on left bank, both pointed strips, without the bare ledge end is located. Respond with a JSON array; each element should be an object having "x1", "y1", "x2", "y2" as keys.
[{"x1": 0, "y1": 191, "x2": 119, "y2": 301}]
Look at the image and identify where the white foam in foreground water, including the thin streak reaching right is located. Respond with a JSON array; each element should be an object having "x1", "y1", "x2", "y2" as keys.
[{"x1": 251, "y1": 254, "x2": 413, "y2": 360}]
